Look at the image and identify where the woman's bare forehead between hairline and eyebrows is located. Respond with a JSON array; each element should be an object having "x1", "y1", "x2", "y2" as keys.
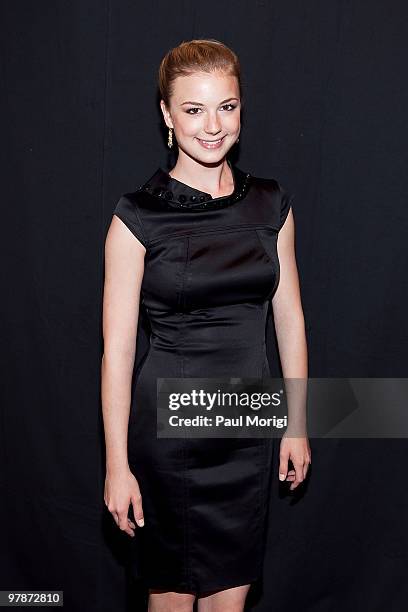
[{"x1": 172, "y1": 71, "x2": 239, "y2": 103}]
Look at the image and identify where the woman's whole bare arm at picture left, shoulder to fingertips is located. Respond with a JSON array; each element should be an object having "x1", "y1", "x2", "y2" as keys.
[{"x1": 101, "y1": 215, "x2": 146, "y2": 535}]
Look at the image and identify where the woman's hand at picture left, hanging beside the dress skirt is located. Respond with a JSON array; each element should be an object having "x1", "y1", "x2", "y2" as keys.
[{"x1": 104, "y1": 469, "x2": 144, "y2": 537}]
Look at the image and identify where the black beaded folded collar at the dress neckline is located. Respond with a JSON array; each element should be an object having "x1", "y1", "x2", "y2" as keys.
[{"x1": 139, "y1": 160, "x2": 251, "y2": 212}]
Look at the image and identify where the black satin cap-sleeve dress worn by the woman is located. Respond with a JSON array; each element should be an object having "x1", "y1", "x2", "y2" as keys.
[{"x1": 114, "y1": 162, "x2": 292, "y2": 594}]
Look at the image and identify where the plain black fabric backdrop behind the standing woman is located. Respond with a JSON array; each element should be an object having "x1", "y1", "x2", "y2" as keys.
[{"x1": 0, "y1": 0, "x2": 408, "y2": 612}]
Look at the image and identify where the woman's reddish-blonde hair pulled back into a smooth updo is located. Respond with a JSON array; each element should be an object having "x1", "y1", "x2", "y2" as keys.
[{"x1": 158, "y1": 38, "x2": 242, "y2": 108}]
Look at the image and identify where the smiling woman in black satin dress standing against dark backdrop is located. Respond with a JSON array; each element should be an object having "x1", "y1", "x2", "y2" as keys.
[{"x1": 102, "y1": 40, "x2": 311, "y2": 612}]
